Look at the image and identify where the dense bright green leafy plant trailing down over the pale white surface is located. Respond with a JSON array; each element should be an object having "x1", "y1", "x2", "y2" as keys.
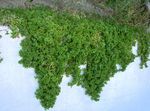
[{"x1": 0, "y1": 7, "x2": 150, "y2": 109}]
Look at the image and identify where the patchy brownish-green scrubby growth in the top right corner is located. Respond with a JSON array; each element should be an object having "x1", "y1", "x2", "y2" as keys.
[{"x1": 105, "y1": 0, "x2": 149, "y2": 28}]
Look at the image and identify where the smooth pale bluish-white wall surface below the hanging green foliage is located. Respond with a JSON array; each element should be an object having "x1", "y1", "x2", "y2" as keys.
[{"x1": 0, "y1": 27, "x2": 150, "y2": 111}]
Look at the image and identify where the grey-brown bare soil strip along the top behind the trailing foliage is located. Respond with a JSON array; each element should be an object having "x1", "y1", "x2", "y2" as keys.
[{"x1": 0, "y1": 0, "x2": 112, "y2": 16}]
